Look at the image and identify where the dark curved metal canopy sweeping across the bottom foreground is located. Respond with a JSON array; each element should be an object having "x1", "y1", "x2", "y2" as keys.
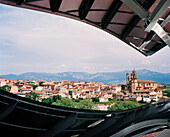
[{"x1": 0, "y1": 90, "x2": 170, "y2": 137}]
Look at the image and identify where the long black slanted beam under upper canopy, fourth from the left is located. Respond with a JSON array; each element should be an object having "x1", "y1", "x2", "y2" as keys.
[{"x1": 101, "y1": 0, "x2": 123, "y2": 29}]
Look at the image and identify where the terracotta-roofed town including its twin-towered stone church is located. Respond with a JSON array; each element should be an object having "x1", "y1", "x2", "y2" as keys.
[{"x1": 0, "y1": 70, "x2": 167, "y2": 106}]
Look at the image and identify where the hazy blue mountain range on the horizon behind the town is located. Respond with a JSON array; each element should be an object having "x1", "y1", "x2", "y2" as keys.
[{"x1": 0, "y1": 69, "x2": 170, "y2": 84}]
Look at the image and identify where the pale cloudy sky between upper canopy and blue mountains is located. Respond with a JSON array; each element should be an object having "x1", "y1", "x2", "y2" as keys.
[{"x1": 0, "y1": 4, "x2": 170, "y2": 75}]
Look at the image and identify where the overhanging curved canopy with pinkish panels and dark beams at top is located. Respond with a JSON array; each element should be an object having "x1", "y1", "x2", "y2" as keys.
[{"x1": 0, "y1": 0, "x2": 170, "y2": 56}]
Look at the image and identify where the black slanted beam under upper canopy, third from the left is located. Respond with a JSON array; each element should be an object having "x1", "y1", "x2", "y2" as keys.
[{"x1": 79, "y1": 0, "x2": 95, "y2": 20}]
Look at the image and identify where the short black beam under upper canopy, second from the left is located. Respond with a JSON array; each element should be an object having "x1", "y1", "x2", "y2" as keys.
[{"x1": 50, "y1": 0, "x2": 62, "y2": 12}]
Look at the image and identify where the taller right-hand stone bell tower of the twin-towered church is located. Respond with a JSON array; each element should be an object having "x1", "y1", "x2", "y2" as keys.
[{"x1": 131, "y1": 69, "x2": 138, "y2": 92}]
